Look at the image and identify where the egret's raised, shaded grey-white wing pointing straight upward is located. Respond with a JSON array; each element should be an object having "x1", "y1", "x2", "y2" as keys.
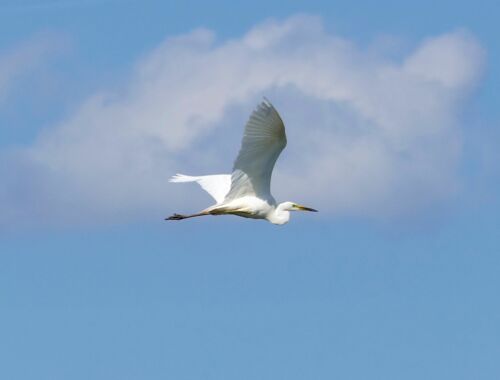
[{"x1": 225, "y1": 98, "x2": 286, "y2": 200}]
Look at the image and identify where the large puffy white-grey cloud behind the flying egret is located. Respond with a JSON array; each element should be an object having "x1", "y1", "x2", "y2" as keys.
[{"x1": 0, "y1": 16, "x2": 483, "y2": 226}]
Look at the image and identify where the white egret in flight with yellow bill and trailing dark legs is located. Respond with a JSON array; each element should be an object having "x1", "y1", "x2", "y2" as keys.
[{"x1": 166, "y1": 98, "x2": 317, "y2": 224}]
